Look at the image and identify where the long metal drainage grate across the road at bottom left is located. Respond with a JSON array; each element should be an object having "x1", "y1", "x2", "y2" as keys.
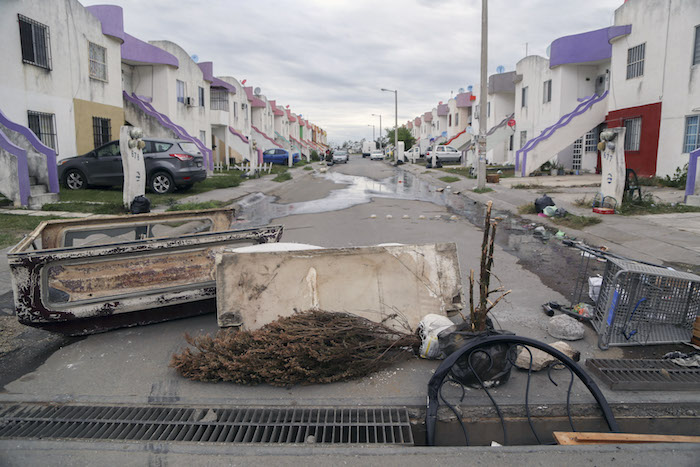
[{"x1": 0, "y1": 404, "x2": 413, "y2": 445}]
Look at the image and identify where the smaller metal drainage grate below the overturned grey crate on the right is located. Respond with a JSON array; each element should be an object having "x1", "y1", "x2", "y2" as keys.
[{"x1": 586, "y1": 358, "x2": 700, "y2": 391}]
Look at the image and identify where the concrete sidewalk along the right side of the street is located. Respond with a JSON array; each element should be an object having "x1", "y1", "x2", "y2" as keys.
[{"x1": 402, "y1": 164, "x2": 700, "y2": 266}]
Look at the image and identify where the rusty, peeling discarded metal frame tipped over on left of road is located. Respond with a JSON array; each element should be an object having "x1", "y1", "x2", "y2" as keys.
[{"x1": 7, "y1": 209, "x2": 282, "y2": 335}]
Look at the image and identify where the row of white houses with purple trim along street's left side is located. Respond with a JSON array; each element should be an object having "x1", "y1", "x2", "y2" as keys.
[{"x1": 0, "y1": 0, "x2": 326, "y2": 204}]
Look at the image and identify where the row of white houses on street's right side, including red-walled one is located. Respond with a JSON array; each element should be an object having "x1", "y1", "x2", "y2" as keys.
[{"x1": 406, "y1": 0, "x2": 700, "y2": 177}]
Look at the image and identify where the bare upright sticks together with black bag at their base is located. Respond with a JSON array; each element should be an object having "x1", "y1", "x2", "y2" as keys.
[{"x1": 438, "y1": 201, "x2": 515, "y2": 388}]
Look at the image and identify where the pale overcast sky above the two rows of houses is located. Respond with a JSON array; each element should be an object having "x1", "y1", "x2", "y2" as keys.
[{"x1": 82, "y1": 0, "x2": 623, "y2": 143}]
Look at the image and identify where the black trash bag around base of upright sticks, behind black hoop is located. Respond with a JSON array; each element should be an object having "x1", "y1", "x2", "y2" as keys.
[{"x1": 438, "y1": 319, "x2": 517, "y2": 389}]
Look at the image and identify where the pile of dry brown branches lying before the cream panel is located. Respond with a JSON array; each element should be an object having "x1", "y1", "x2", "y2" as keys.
[{"x1": 170, "y1": 311, "x2": 420, "y2": 386}]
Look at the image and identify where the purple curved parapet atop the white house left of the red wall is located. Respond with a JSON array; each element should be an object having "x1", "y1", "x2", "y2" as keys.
[{"x1": 549, "y1": 28, "x2": 621, "y2": 68}]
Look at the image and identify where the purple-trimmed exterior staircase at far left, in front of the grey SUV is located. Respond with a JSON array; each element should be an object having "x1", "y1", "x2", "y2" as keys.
[{"x1": 0, "y1": 111, "x2": 59, "y2": 209}]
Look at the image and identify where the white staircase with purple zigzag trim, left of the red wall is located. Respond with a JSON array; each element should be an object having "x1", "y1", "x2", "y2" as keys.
[{"x1": 515, "y1": 91, "x2": 608, "y2": 177}]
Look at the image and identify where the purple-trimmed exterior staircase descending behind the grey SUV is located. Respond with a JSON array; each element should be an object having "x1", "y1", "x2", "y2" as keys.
[{"x1": 122, "y1": 91, "x2": 214, "y2": 173}]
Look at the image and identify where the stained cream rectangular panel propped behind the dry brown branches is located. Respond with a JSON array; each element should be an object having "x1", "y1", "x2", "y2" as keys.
[{"x1": 216, "y1": 243, "x2": 464, "y2": 330}]
